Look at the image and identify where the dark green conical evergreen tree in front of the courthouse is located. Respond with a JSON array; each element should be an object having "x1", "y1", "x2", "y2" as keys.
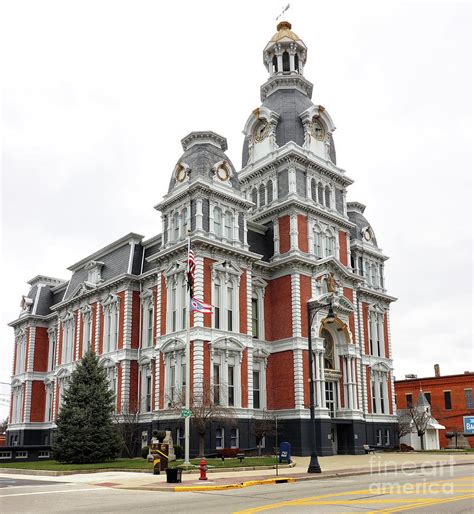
[{"x1": 53, "y1": 352, "x2": 120, "y2": 463}]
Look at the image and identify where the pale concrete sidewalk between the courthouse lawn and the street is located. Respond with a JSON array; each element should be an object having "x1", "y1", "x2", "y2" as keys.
[{"x1": 0, "y1": 453, "x2": 474, "y2": 492}]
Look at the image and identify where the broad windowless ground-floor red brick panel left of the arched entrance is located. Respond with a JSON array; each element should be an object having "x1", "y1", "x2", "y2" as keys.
[{"x1": 265, "y1": 350, "x2": 295, "y2": 409}]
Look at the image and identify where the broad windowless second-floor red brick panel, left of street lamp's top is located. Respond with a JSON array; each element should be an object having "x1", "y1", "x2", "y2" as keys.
[{"x1": 264, "y1": 275, "x2": 293, "y2": 341}]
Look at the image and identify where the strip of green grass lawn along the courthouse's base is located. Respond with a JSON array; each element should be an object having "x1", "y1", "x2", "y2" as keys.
[{"x1": 0, "y1": 457, "x2": 275, "y2": 472}]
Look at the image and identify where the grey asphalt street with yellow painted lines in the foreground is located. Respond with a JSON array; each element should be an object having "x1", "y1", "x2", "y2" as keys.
[{"x1": 0, "y1": 465, "x2": 474, "y2": 514}]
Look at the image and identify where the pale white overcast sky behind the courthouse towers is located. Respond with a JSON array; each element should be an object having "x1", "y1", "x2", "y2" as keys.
[{"x1": 0, "y1": 0, "x2": 473, "y2": 417}]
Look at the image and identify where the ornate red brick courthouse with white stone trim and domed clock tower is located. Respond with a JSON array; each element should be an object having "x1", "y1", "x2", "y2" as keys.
[{"x1": 8, "y1": 22, "x2": 396, "y2": 455}]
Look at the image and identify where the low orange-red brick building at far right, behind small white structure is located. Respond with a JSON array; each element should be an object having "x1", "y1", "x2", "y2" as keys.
[{"x1": 395, "y1": 371, "x2": 474, "y2": 448}]
